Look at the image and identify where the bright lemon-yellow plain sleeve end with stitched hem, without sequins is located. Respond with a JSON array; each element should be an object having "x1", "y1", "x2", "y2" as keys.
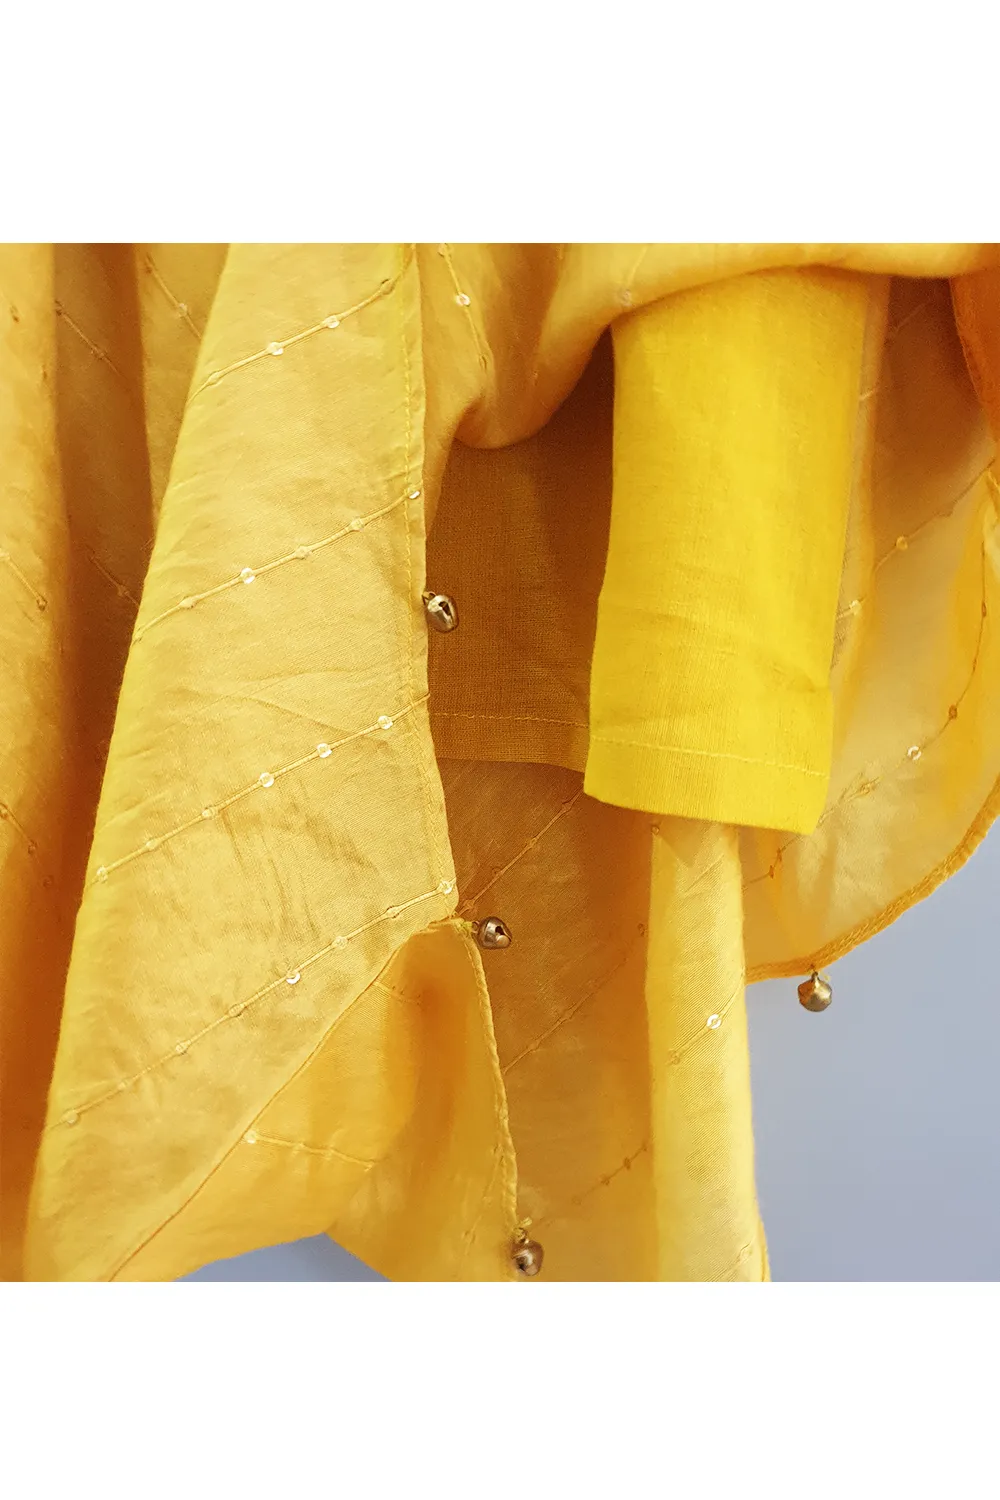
[{"x1": 585, "y1": 269, "x2": 870, "y2": 833}]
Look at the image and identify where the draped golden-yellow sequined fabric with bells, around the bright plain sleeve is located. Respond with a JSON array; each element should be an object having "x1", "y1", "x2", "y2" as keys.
[{"x1": 0, "y1": 245, "x2": 1000, "y2": 1280}]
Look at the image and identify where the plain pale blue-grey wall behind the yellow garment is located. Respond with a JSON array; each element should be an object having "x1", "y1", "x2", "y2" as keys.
[{"x1": 184, "y1": 828, "x2": 1000, "y2": 1281}]
